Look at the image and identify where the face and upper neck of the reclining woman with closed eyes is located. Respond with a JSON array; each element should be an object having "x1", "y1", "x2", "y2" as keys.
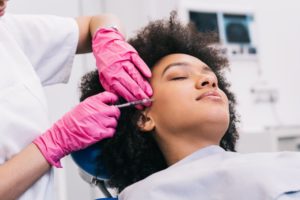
[{"x1": 147, "y1": 54, "x2": 229, "y2": 144}]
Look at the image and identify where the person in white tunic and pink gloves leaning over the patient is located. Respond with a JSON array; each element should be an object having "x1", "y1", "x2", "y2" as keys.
[{"x1": 0, "y1": 0, "x2": 152, "y2": 200}]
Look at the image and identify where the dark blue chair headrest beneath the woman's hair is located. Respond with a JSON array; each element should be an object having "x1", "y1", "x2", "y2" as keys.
[{"x1": 71, "y1": 143, "x2": 117, "y2": 200}]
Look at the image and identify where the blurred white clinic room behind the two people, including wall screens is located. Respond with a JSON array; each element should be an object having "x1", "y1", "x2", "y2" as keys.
[{"x1": 8, "y1": 0, "x2": 300, "y2": 200}]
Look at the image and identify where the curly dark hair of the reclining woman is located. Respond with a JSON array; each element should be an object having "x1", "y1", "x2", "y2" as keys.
[{"x1": 81, "y1": 12, "x2": 238, "y2": 192}]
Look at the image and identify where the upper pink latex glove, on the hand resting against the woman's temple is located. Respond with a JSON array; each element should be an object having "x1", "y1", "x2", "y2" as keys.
[{"x1": 92, "y1": 28, "x2": 153, "y2": 104}]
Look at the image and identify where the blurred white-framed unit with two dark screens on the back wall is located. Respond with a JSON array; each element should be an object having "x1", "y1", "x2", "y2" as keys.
[{"x1": 178, "y1": 0, "x2": 257, "y2": 59}]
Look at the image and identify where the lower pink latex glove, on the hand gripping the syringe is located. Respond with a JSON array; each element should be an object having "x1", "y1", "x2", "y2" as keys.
[{"x1": 33, "y1": 92, "x2": 120, "y2": 167}]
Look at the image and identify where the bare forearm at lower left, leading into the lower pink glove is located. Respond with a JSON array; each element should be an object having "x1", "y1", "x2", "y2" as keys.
[{"x1": 0, "y1": 144, "x2": 50, "y2": 200}]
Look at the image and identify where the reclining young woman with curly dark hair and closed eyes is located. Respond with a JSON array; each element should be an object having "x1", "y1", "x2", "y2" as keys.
[{"x1": 82, "y1": 14, "x2": 300, "y2": 200}]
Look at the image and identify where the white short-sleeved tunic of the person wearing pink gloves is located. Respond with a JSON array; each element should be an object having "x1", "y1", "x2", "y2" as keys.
[{"x1": 0, "y1": 14, "x2": 79, "y2": 200}]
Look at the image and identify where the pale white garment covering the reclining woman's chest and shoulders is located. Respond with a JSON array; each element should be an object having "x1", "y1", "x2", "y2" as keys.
[{"x1": 119, "y1": 146, "x2": 300, "y2": 200}]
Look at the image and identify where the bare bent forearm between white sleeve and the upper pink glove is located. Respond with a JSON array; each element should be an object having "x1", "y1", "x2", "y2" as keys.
[{"x1": 76, "y1": 14, "x2": 125, "y2": 54}]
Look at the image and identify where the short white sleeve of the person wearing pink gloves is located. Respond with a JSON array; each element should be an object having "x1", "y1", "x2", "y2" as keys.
[{"x1": 2, "y1": 15, "x2": 79, "y2": 85}]
